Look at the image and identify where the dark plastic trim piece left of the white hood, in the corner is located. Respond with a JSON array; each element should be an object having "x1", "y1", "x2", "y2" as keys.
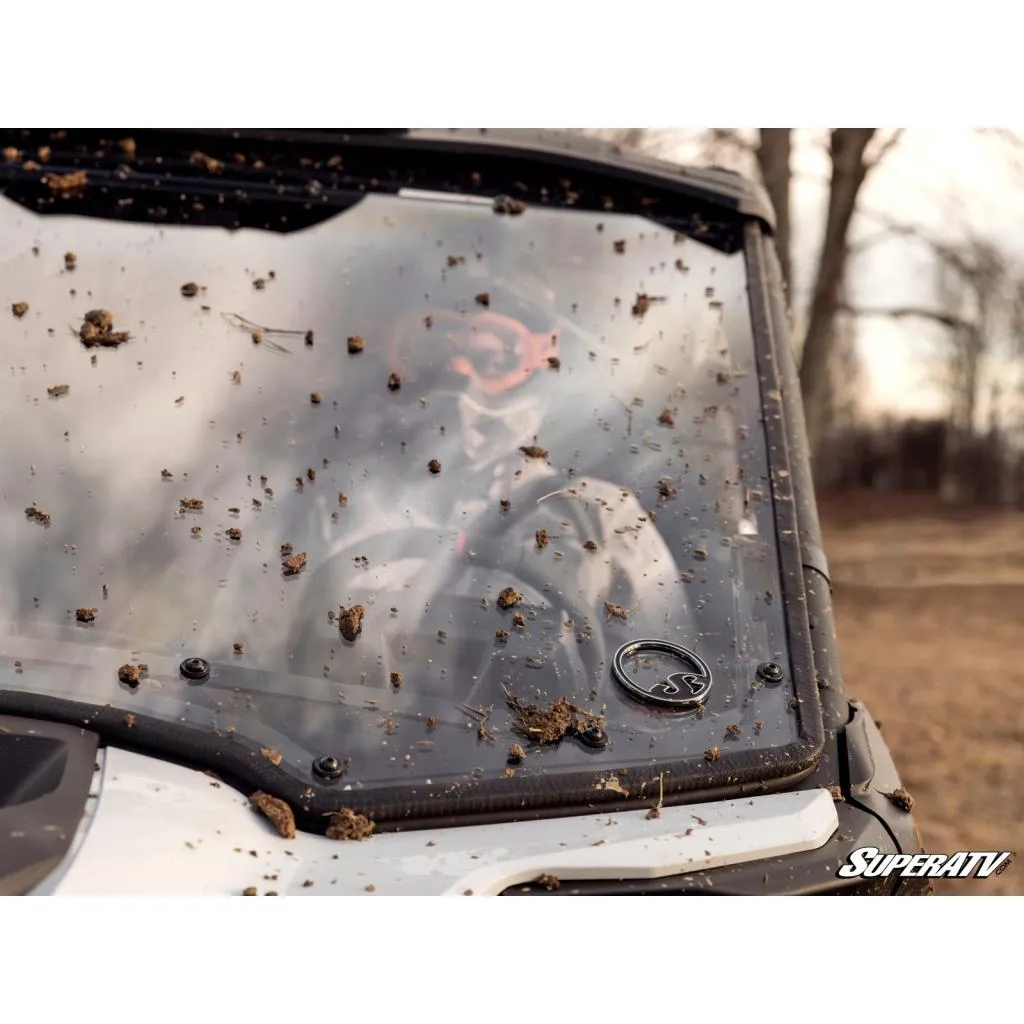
[{"x1": 0, "y1": 714, "x2": 99, "y2": 896}]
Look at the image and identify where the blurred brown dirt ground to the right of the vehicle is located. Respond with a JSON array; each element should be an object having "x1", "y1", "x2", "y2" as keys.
[{"x1": 820, "y1": 496, "x2": 1024, "y2": 895}]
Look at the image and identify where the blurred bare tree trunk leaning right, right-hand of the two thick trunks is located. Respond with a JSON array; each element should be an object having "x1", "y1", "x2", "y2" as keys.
[{"x1": 800, "y1": 128, "x2": 876, "y2": 453}]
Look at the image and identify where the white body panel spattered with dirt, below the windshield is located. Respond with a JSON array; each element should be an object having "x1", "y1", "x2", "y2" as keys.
[{"x1": 33, "y1": 750, "x2": 839, "y2": 896}]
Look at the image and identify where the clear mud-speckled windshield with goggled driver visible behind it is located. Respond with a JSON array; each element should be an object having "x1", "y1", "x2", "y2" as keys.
[{"x1": 0, "y1": 196, "x2": 798, "y2": 786}]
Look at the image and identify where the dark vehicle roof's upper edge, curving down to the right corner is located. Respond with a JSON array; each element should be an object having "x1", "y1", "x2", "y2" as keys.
[{"x1": 157, "y1": 128, "x2": 775, "y2": 232}]
